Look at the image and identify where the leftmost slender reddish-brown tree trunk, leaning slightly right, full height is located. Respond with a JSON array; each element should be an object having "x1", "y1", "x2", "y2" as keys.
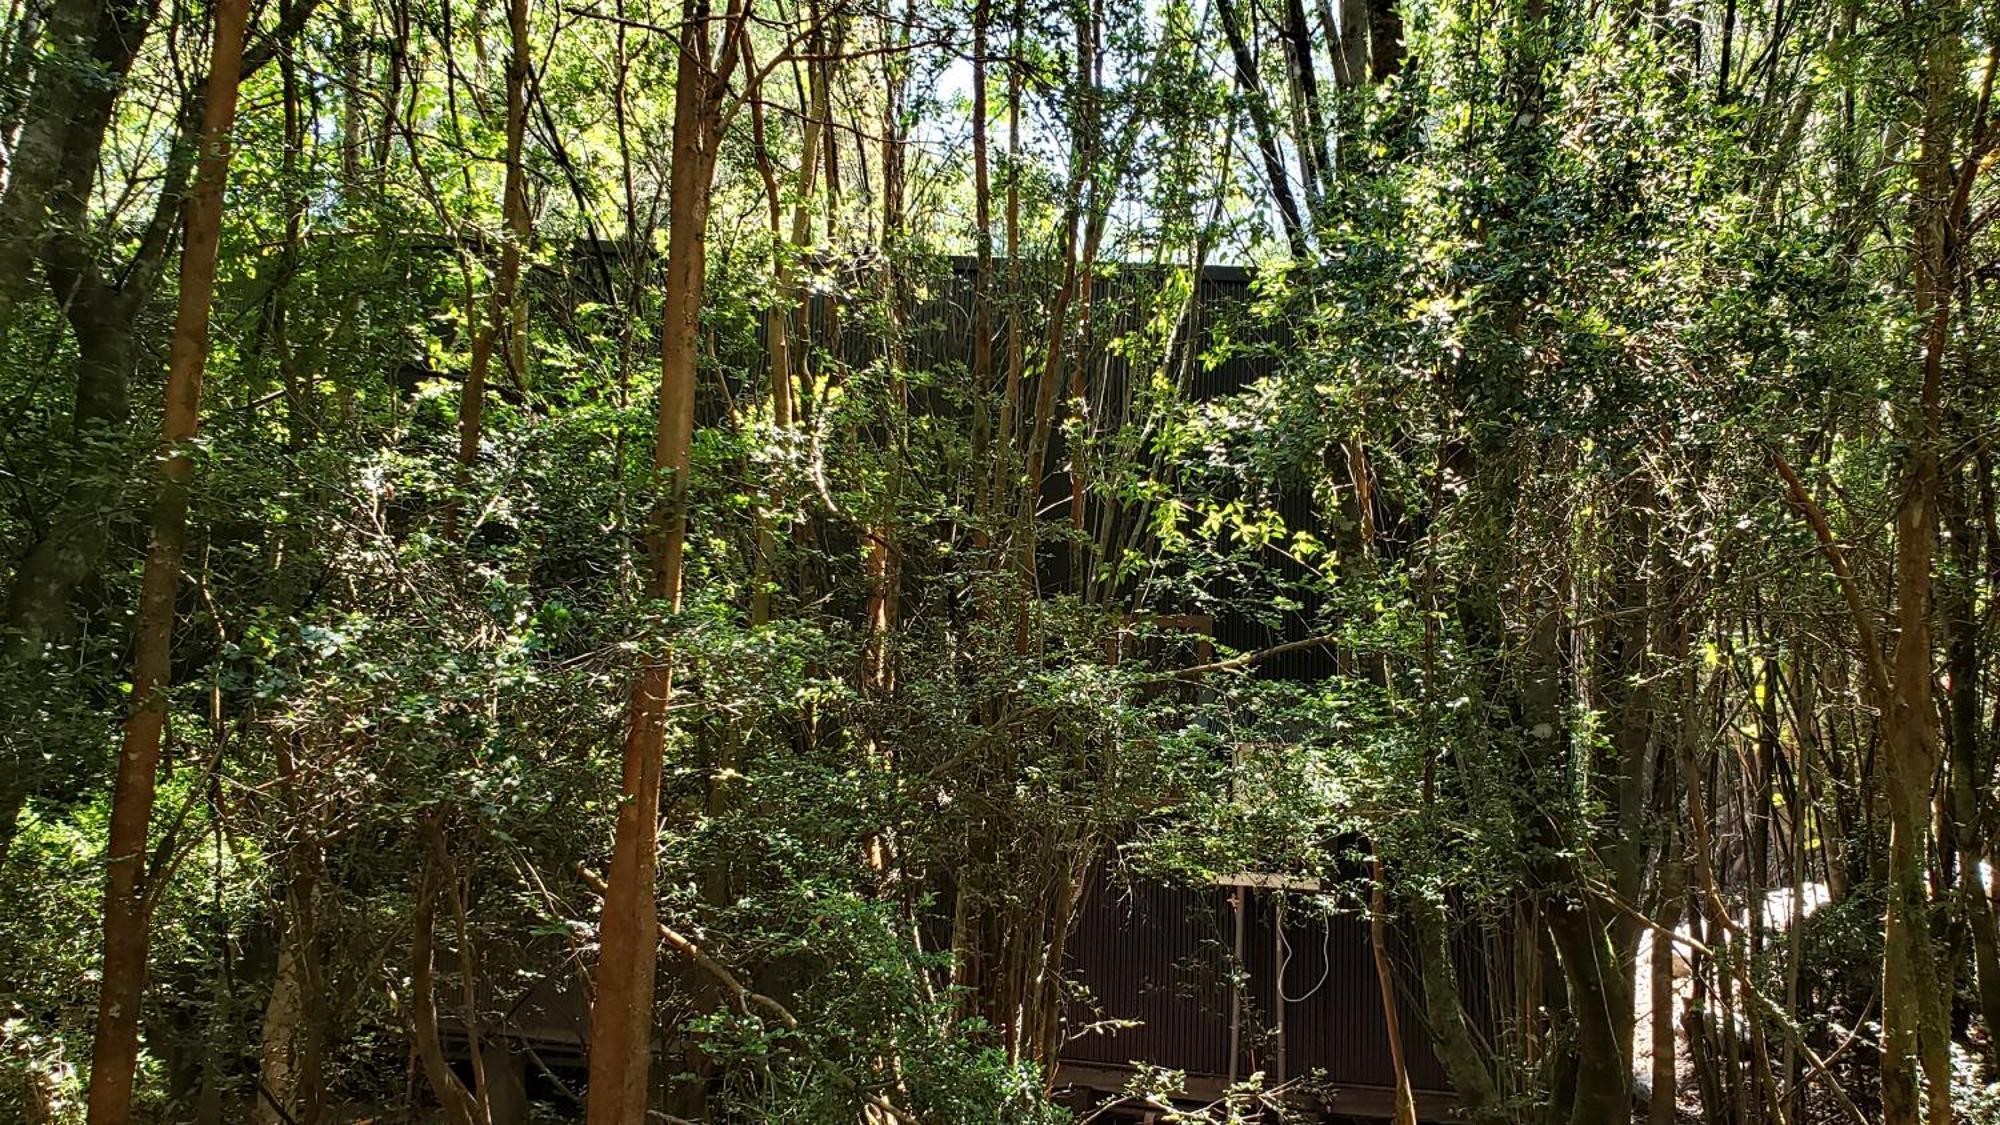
[{"x1": 90, "y1": 0, "x2": 250, "y2": 1125}]
